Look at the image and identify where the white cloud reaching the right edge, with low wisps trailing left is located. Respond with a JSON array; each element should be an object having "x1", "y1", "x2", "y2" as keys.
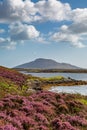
[{"x1": 51, "y1": 8, "x2": 87, "y2": 48}]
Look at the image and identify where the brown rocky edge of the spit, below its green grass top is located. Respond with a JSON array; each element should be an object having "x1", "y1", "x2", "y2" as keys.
[{"x1": 27, "y1": 77, "x2": 87, "y2": 90}]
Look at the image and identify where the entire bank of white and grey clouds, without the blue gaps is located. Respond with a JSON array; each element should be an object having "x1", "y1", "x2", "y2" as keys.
[{"x1": 0, "y1": 0, "x2": 87, "y2": 48}]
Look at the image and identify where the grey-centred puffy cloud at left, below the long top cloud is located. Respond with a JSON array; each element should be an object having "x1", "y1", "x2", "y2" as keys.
[{"x1": 0, "y1": 22, "x2": 40, "y2": 50}]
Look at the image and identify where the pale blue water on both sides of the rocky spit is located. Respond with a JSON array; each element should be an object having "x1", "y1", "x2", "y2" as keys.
[{"x1": 20, "y1": 72, "x2": 87, "y2": 95}]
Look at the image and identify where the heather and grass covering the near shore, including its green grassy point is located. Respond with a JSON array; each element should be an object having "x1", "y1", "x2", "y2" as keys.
[{"x1": 0, "y1": 67, "x2": 87, "y2": 130}]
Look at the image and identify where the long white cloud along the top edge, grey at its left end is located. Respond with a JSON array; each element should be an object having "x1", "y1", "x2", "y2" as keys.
[{"x1": 0, "y1": 0, "x2": 71, "y2": 23}]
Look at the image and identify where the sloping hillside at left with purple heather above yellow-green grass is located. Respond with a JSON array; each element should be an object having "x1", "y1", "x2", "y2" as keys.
[{"x1": 0, "y1": 66, "x2": 27, "y2": 98}]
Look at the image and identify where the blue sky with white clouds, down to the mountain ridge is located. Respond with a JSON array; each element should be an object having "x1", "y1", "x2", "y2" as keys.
[{"x1": 0, "y1": 0, "x2": 87, "y2": 68}]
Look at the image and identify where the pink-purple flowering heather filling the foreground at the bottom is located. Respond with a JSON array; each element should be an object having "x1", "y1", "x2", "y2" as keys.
[{"x1": 0, "y1": 91, "x2": 87, "y2": 130}]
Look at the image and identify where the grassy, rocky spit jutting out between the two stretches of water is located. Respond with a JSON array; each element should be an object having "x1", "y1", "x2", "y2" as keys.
[{"x1": 27, "y1": 76, "x2": 87, "y2": 91}]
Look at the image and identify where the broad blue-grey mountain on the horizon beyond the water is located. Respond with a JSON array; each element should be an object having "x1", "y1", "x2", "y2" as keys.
[{"x1": 15, "y1": 58, "x2": 80, "y2": 69}]
